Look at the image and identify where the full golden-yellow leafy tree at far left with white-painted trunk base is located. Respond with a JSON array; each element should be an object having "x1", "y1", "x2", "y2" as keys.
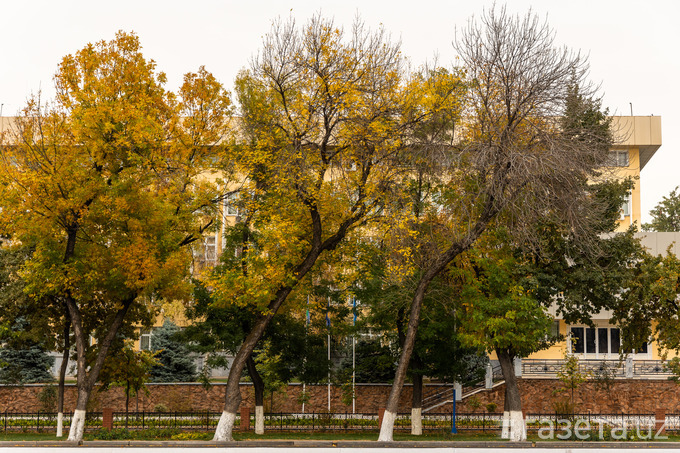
[{"x1": 0, "y1": 32, "x2": 229, "y2": 441}]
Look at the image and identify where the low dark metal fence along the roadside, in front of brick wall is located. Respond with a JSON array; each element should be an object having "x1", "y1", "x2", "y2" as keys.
[{"x1": 0, "y1": 411, "x2": 680, "y2": 433}]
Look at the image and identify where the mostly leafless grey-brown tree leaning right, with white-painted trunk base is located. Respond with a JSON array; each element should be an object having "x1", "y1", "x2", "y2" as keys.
[{"x1": 379, "y1": 7, "x2": 609, "y2": 441}]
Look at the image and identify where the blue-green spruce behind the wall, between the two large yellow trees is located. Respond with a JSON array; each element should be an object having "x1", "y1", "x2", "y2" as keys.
[{"x1": 150, "y1": 320, "x2": 197, "y2": 382}]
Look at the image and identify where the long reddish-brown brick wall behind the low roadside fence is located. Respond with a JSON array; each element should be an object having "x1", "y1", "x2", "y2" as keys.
[{"x1": 5, "y1": 379, "x2": 680, "y2": 413}]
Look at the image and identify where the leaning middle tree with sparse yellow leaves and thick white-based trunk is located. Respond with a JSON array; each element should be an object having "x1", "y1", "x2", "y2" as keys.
[{"x1": 209, "y1": 16, "x2": 462, "y2": 441}]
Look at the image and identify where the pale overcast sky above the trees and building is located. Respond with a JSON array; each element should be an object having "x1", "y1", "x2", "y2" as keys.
[{"x1": 0, "y1": 0, "x2": 680, "y2": 221}]
